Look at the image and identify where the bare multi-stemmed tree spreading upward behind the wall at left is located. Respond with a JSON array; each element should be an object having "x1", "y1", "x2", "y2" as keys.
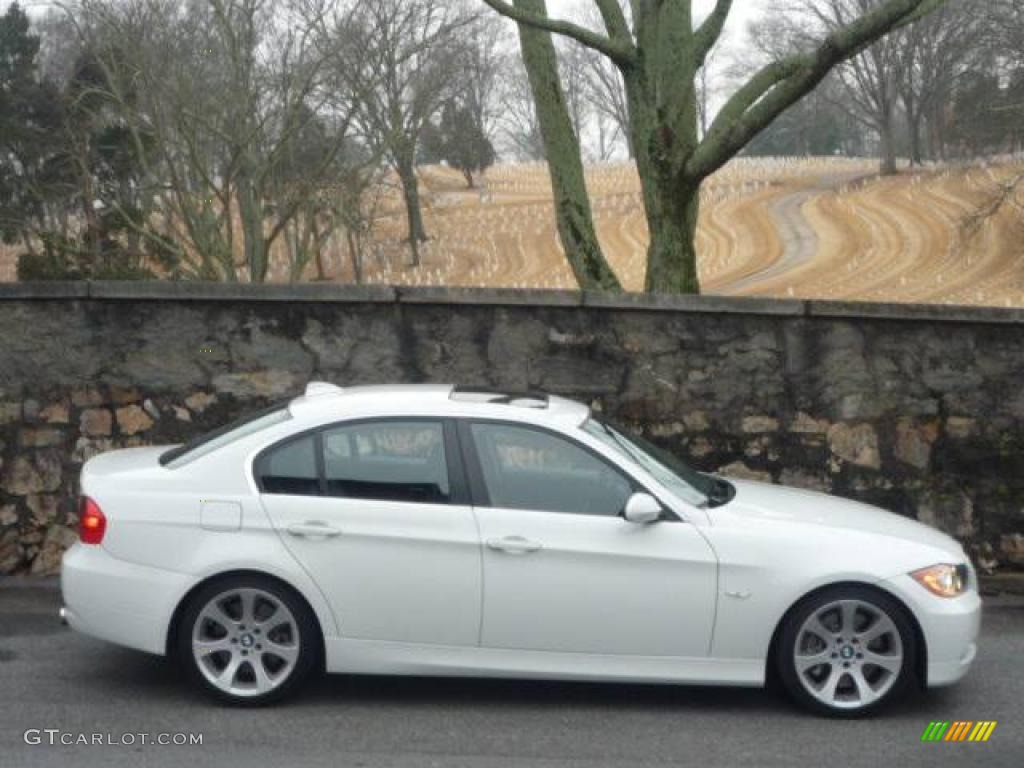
[{"x1": 73, "y1": 0, "x2": 360, "y2": 282}]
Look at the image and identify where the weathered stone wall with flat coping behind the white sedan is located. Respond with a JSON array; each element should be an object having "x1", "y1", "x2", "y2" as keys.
[{"x1": 0, "y1": 283, "x2": 1024, "y2": 573}]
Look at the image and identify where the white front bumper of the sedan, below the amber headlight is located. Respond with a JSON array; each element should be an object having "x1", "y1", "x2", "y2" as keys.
[{"x1": 888, "y1": 575, "x2": 981, "y2": 688}]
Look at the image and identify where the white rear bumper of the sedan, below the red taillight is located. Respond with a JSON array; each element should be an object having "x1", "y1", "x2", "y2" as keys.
[{"x1": 60, "y1": 544, "x2": 188, "y2": 655}]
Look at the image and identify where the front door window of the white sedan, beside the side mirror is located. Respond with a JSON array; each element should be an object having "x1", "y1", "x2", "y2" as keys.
[{"x1": 471, "y1": 423, "x2": 633, "y2": 515}]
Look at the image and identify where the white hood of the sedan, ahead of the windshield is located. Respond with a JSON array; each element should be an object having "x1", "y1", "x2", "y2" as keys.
[{"x1": 728, "y1": 478, "x2": 966, "y2": 562}]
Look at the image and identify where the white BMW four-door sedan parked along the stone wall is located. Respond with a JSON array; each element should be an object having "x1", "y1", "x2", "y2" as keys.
[{"x1": 61, "y1": 383, "x2": 981, "y2": 716}]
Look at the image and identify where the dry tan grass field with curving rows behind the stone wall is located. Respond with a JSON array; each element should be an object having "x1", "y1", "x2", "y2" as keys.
[{"x1": 0, "y1": 158, "x2": 1024, "y2": 306}]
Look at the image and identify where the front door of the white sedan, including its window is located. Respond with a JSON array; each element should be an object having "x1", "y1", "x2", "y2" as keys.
[{"x1": 460, "y1": 421, "x2": 717, "y2": 656}]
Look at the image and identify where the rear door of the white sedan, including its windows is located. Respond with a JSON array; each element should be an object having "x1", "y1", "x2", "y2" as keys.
[{"x1": 256, "y1": 419, "x2": 481, "y2": 646}]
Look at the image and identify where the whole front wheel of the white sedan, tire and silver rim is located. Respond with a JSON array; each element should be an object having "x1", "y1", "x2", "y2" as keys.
[{"x1": 775, "y1": 586, "x2": 919, "y2": 718}]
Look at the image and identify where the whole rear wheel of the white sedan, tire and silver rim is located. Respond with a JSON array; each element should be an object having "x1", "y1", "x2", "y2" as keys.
[{"x1": 177, "y1": 574, "x2": 323, "y2": 707}]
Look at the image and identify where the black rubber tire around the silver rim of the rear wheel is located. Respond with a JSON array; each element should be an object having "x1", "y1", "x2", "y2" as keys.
[{"x1": 176, "y1": 573, "x2": 323, "y2": 707}]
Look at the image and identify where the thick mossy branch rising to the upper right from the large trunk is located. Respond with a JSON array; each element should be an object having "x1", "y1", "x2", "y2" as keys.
[{"x1": 685, "y1": 0, "x2": 946, "y2": 179}]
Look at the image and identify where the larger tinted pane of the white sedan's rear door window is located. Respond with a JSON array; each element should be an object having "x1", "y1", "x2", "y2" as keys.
[{"x1": 324, "y1": 421, "x2": 452, "y2": 504}]
